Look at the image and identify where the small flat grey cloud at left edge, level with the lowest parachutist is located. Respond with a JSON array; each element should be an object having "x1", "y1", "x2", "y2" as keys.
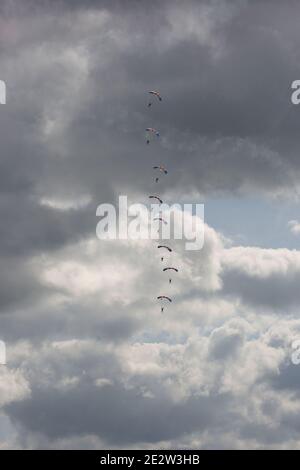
[{"x1": 1, "y1": 300, "x2": 142, "y2": 344}]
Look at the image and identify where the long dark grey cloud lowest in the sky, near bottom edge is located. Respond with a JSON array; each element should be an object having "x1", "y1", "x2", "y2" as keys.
[{"x1": 6, "y1": 383, "x2": 230, "y2": 445}]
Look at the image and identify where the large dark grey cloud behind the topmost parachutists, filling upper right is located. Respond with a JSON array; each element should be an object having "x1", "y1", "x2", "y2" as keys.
[{"x1": 47, "y1": 2, "x2": 300, "y2": 193}]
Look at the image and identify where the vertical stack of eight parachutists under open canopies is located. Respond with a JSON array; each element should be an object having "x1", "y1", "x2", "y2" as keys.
[{"x1": 146, "y1": 90, "x2": 178, "y2": 313}]
